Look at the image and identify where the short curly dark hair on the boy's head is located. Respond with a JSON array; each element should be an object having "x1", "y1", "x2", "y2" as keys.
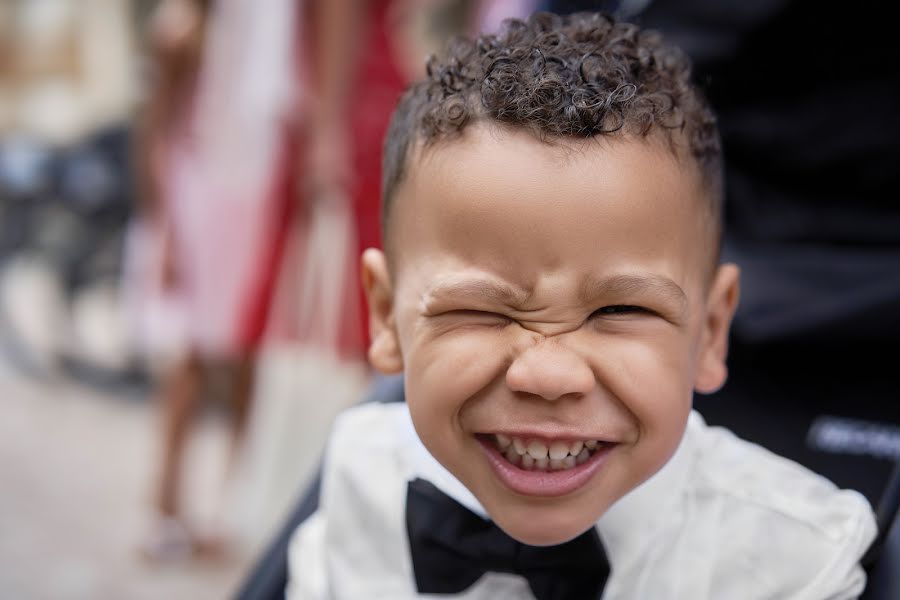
[{"x1": 381, "y1": 13, "x2": 722, "y2": 239}]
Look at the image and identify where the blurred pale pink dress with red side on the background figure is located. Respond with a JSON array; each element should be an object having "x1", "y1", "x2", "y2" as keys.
[{"x1": 126, "y1": 0, "x2": 298, "y2": 358}]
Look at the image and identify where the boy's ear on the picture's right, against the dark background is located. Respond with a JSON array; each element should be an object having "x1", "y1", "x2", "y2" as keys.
[{"x1": 694, "y1": 264, "x2": 741, "y2": 394}]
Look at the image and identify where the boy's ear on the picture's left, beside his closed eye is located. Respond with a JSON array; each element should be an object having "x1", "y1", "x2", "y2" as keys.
[{"x1": 360, "y1": 248, "x2": 403, "y2": 375}]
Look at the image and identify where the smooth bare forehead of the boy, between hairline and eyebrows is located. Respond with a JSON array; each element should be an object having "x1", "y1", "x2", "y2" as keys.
[{"x1": 389, "y1": 125, "x2": 711, "y2": 300}]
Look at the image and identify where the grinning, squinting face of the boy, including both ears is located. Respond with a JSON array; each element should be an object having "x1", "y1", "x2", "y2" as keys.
[{"x1": 364, "y1": 125, "x2": 738, "y2": 545}]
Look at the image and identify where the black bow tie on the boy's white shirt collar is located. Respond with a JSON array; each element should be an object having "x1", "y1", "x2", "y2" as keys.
[{"x1": 406, "y1": 479, "x2": 609, "y2": 600}]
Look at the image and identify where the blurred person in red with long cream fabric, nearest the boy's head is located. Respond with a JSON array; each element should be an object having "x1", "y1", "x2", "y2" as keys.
[{"x1": 230, "y1": 0, "x2": 416, "y2": 539}]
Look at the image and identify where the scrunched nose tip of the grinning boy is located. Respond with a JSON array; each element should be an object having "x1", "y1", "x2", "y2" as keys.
[{"x1": 506, "y1": 338, "x2": 594, "y2": 400}]
